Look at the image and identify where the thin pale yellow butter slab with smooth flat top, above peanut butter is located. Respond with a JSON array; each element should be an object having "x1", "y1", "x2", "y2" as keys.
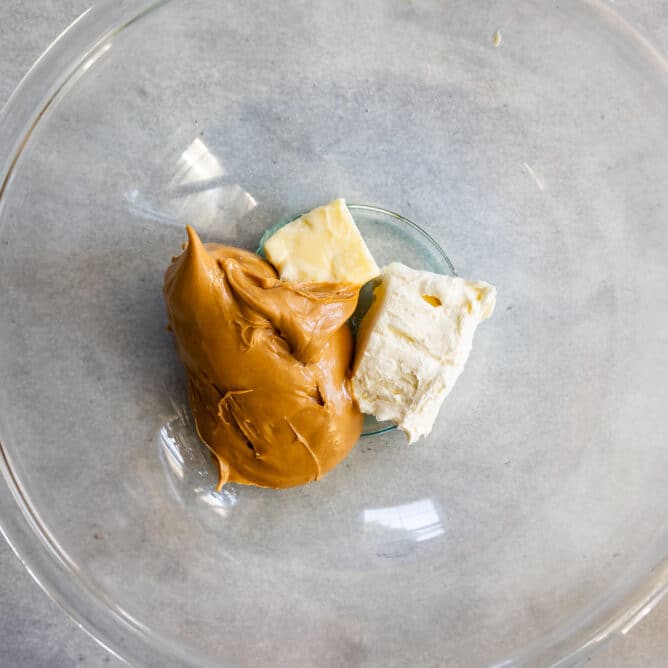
[{"x1": 264, "y1": 199, "x2": 378, "y2": 285}]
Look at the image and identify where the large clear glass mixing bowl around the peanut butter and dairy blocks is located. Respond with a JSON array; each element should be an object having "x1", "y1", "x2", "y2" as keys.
[{"x1": 0, "y1": 0, "x2": 668, "y2": 668}]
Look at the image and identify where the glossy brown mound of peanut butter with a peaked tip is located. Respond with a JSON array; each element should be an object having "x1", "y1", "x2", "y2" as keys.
[{"x1": 164, "y1": 227, "x2": 363, "y2": 489}]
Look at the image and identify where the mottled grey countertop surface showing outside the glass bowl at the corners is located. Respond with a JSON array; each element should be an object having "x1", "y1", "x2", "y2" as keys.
[{"x1": 0, "y1": 0, "x2": 668, "y2": 668}]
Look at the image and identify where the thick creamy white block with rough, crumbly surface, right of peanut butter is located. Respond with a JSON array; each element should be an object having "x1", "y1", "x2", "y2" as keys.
[{"x1": 352, "y1": 262, "x2": 496, "y2": 443}]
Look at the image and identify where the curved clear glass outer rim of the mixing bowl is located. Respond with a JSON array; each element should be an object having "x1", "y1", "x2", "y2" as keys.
[{"x1": 0, "y1": 0, "x2": 668, "y2": 668}]
